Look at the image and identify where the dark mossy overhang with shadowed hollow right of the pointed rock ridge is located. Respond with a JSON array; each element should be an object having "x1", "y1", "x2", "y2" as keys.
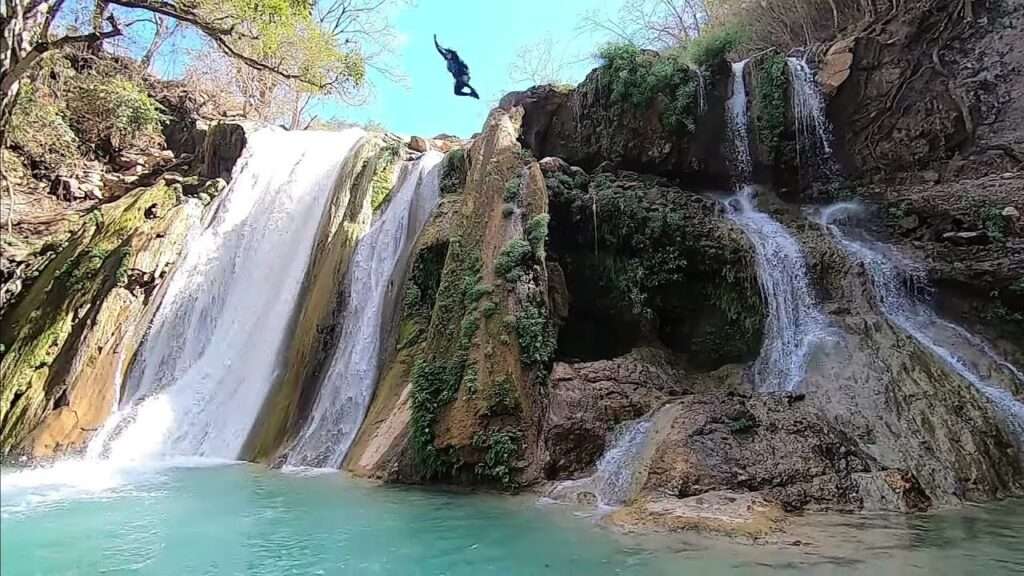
[{"x1": 547, "y1": 164, "x2": 765, "y2": 369}]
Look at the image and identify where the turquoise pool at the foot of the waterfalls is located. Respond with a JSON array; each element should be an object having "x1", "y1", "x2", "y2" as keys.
[{"x1": 0, "y1": 462, "x2": 1024, "y2": 576}]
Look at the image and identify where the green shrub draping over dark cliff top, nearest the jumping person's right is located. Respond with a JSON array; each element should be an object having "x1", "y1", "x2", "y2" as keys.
[{"x1": 598, "y1": 43, "x2": 697, "y2": 133}]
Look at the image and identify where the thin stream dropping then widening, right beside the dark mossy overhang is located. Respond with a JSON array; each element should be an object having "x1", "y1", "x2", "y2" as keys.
[{"x1": 723, "y1": 60, "x2": 826, "y2": 392}]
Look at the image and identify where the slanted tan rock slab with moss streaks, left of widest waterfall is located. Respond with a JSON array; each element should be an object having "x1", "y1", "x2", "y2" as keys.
[{"x1": 0, "y1": 184, "x2": 201, "y2": 456}]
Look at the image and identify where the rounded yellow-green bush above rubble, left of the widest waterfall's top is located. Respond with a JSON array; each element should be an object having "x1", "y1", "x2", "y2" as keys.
[{"x1": 68, "y1": 74, "x2": 165, "y2": 150}]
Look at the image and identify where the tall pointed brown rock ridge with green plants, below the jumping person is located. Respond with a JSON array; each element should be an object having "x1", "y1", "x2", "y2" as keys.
[{"x1": 346, "y1": 111, "x2": 554, "y2": 487}]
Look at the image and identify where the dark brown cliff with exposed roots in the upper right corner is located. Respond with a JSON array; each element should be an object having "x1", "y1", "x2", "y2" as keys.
[{"x1": 819, "y1": 0, "x2": 1024, "y2": 177}]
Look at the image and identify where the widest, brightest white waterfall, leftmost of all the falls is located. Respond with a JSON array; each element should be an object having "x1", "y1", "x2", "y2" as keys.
[{"x1": 88, "y1": 129, "x2": 364, "y2": 462}]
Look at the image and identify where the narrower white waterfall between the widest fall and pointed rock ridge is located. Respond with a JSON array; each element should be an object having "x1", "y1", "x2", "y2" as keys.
[{"x1": 287, "y1": 152, "x2": 442, "y2": 468}]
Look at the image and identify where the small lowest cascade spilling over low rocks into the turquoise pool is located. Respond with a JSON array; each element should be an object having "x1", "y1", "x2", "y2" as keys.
[{"x1": 549, "y1": 418, "x2": 652, "y2": 507}]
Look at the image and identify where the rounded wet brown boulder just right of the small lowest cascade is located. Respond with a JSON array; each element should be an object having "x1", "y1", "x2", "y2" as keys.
[{"x1": 644, "y1": 394, "x2": 876, "y2": 510}]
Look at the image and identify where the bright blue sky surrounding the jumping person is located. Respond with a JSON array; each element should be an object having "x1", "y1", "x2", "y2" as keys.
[{"x1": 318, "y1": 0, "x2": 618, "y2": 136}]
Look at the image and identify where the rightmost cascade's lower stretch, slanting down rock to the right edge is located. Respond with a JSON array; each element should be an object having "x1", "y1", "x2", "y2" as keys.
[{"x1": 819, "y1": 202, "x2": 1024, "y2": 444}]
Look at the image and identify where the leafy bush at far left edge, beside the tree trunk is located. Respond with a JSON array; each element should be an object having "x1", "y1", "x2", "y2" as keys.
[{"x1": 10, "y1": 84, "x2": 81, "y2": 173}]
